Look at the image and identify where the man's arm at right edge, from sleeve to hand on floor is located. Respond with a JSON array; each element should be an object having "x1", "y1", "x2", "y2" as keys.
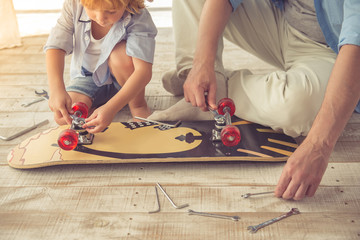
[{"x1": 275, "y1": 45, "x2": 360, "y2": 200}]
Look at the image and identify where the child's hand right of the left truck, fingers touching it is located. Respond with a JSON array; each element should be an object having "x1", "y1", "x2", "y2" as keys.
[{"x1": 83, "y1": 104, "x2": 116, "y2": 133}]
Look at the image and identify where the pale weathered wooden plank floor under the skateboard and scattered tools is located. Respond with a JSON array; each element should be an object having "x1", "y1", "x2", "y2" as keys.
[{"x1": 0, "y1": 28, "x2": 360, "y2": 240}]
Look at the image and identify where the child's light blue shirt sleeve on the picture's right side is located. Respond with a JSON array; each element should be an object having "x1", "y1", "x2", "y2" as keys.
[{"x1": 126, "y1": 9, "x2": 157, "y2": 63}]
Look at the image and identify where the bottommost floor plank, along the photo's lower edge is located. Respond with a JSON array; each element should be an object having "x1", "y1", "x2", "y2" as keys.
[{"x1": 0, "y1": 211, "x2": 360, "y2": 240}]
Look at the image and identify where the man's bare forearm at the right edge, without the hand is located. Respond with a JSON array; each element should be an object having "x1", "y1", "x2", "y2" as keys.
[{"x1": 308, "y1": 45, "x2": 360, "y2": 149}]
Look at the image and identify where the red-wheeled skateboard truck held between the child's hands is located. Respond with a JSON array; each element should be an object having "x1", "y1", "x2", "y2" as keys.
[{"x1": 58, "y1": 102, "x2": 94, "y2": 151}]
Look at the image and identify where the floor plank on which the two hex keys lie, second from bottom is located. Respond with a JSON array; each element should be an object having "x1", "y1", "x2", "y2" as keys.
[{"x1": 0, "y1": 183, "x2": 360, "y2": 213}]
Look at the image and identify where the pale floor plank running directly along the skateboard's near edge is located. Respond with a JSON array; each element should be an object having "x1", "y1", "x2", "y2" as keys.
[{"x1": 0, "y1": 162, "x2": 360, "y2": 187}]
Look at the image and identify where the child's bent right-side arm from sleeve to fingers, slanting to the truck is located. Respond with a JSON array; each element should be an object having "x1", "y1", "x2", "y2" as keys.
[{"x1": 83, "y1": 57, "x2": 152, "y2": 133}]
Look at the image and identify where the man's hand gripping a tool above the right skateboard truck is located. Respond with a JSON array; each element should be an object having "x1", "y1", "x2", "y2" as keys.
[{"x1": 184, "y1": 61, "x2": 217, "y2": 111}]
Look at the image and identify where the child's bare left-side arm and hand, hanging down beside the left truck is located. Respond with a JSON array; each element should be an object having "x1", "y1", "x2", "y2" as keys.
[{"x1": 46, "y1": 49, "x2": 72, "y2": 124}]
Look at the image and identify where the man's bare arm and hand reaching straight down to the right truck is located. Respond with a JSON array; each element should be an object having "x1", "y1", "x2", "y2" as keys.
[{"x1": 184, "y1": 0, "x2": 232, "y2": 111}]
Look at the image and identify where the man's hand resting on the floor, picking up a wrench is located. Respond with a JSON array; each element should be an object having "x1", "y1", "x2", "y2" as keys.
[{"x1": 275, "y1": 139, "x2": 332, "y2": 200}]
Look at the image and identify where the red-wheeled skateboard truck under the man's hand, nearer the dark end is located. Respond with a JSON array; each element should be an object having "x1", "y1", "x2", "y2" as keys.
[{"x1": 208, "y1": 98, "x2": 241, "y2": 147}]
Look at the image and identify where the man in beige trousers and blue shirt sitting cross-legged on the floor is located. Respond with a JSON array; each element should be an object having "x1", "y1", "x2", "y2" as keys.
[{"x1": 150, "y1": 0, "x2": 360, "y2": 200}]
